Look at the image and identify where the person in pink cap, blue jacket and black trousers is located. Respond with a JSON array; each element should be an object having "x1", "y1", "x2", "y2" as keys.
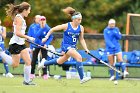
[{"x1": 31, "y1": 16, "x2": 53, "y2": 80}]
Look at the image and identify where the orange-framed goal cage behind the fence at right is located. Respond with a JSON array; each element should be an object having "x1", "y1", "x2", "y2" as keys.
[{"x1": 125, "y1": 13, "x2": 140, "y2": 52}]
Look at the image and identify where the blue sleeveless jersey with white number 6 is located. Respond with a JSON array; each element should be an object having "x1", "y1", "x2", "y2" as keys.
[{"x1": 61, "y1": 22, "x2": 81, "y2": 52}]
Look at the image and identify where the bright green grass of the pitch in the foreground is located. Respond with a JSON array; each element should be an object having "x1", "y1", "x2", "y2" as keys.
[{"x1": 0, "y1": 76, "x2": 140, "y2": 93}]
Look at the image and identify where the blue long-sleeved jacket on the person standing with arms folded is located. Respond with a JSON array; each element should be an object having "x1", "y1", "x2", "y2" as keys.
[{"x1": 104, "y1": 27, "x2": 122, "y2": 51}]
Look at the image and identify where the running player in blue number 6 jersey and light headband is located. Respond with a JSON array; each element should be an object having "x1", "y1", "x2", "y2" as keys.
[{"x1": 38, "y1": 7, "x2": 90, "y2": 84}]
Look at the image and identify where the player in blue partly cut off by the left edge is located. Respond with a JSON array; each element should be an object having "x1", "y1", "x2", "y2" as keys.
[{"x1": 0, "y1": 20, "x2": 14, "y2": 78}]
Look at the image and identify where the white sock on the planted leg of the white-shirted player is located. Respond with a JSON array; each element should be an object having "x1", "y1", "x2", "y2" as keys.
[{"x1": 24, "y1": 65, "x2": 31, "y2": 82}]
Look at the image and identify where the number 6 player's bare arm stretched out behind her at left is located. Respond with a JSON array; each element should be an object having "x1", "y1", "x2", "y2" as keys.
[{"x1": 42, "y1": 24, "x2": 67, "y2": 42}]
